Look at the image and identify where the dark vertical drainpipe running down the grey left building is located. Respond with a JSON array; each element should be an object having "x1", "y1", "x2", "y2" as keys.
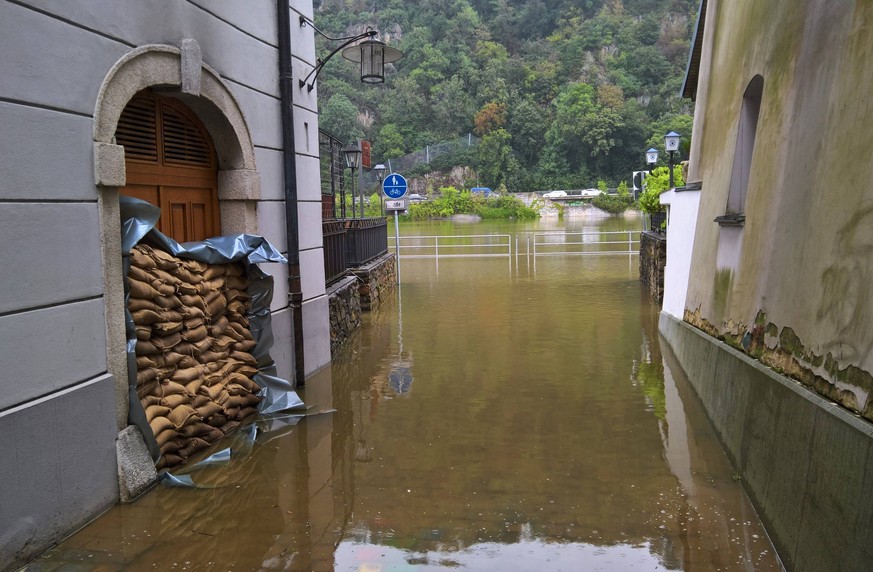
[{"x1": 276, "y1": 0, "x2": 304, "y2": 385}]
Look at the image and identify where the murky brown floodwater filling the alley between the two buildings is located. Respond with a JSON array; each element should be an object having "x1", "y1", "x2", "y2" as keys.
[{"x1": 29, "y1": 218, "x2": 781, "y2": 572}]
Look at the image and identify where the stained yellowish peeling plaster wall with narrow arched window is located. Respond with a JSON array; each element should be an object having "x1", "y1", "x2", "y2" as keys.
[{"x1": 685, "y1": 0, "x2": 873, "y2": 412}]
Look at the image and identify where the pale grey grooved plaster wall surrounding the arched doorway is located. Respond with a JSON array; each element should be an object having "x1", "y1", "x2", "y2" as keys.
[{"x1": 0, "y1": 0, "x2": 320, "y2": 568}]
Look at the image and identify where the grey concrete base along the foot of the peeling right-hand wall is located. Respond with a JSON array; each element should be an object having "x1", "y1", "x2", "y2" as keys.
[{"x1": 659, "y1": 313, "x2": 873, "y2": 571}]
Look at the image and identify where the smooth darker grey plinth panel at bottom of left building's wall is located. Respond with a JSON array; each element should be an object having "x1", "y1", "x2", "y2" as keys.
[{"x1": 0, "y1": 374, "x2": 118, "y2": 569}]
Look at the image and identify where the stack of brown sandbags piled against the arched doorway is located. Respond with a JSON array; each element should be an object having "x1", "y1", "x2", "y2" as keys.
[{"x1": 127, "y1": 245, "x2": 261, "y2": 469}]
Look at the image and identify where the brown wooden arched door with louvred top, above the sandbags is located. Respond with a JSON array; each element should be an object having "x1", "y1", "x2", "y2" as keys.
[{"x1": 115, "y1": 90, "x2": 221, "y2": 242}]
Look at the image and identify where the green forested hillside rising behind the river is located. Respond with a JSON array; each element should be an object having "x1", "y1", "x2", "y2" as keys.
[{"x1": 315, "y1": 0, "x2": 698, "y2": 191}]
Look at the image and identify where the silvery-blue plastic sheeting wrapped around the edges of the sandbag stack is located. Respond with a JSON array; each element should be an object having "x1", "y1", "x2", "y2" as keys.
[{"x1": 119, "y1": 195, "x2": 305, "y2": 461}]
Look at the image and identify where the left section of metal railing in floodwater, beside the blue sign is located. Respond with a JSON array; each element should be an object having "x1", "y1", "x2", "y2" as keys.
[{"x1": 389, "y1": 234, "x2": 512, "y2": 258}]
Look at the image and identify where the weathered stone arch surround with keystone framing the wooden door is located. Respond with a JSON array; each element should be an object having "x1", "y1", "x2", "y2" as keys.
[{"x1": 93, "y1": 39, "x2": 260, "y2": 429}]
